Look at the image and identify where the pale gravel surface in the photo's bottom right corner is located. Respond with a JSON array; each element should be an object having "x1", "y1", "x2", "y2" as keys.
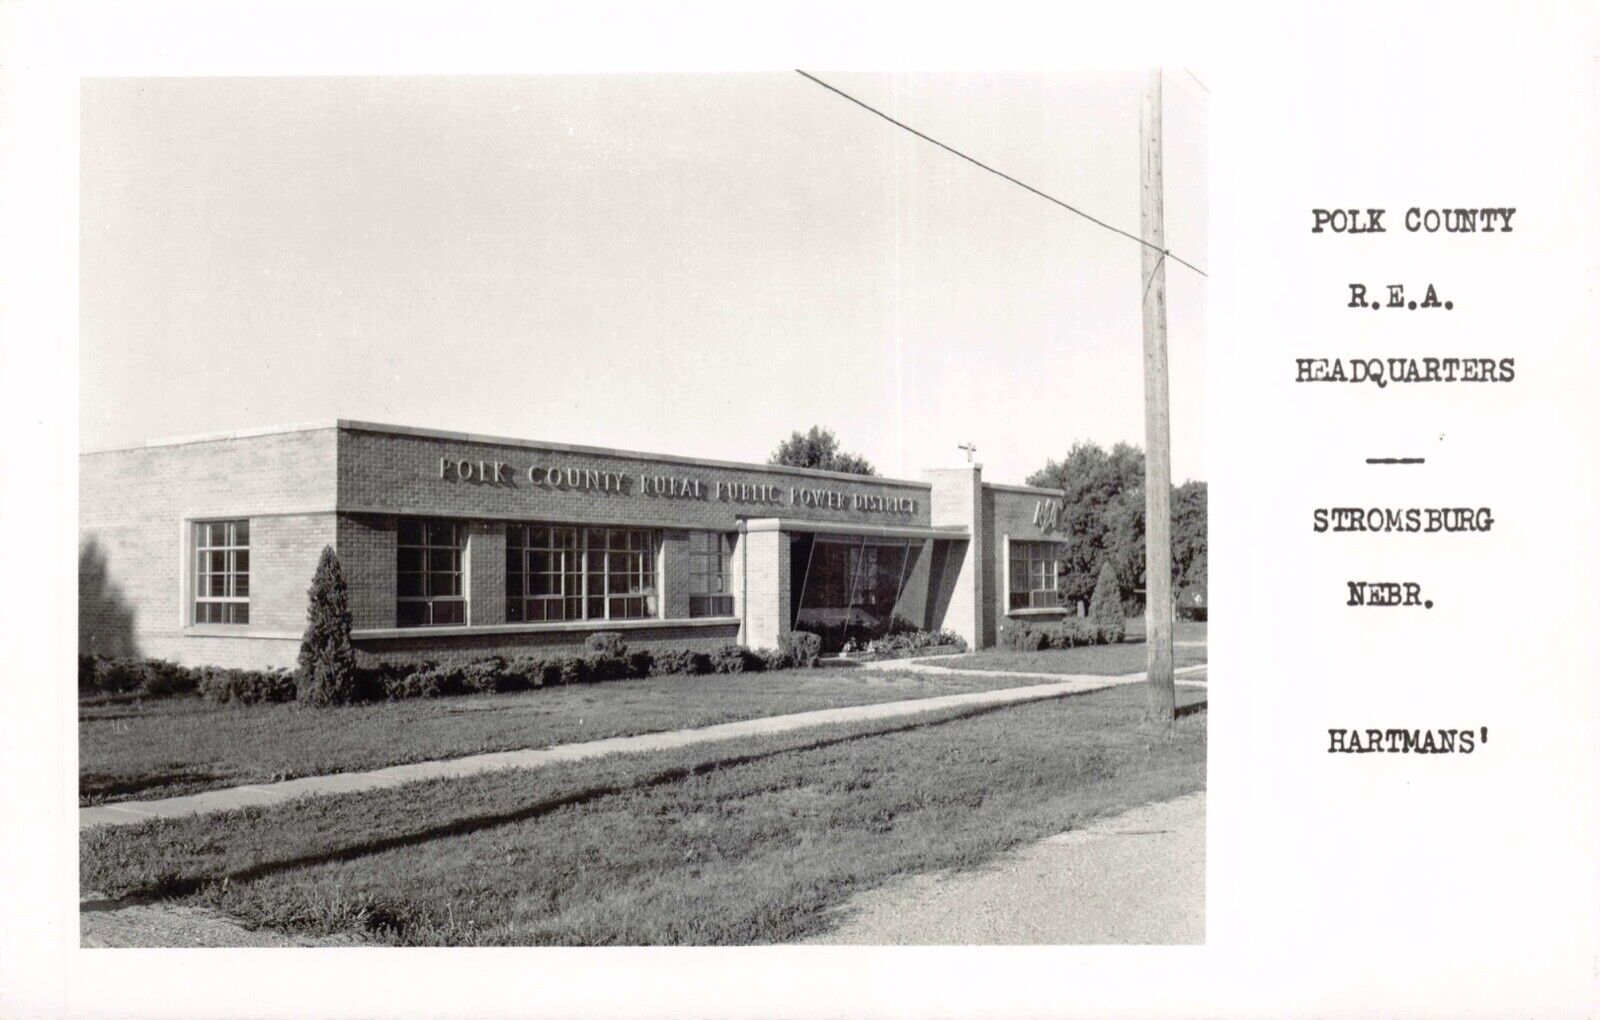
[{"x1": 808, "y1": 791, "x2": 1205, "y2": 945}]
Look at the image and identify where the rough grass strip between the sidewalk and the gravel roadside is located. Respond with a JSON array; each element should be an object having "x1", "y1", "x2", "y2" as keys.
[{"x1": 80, "y1": 687, "x2": 1206, "y2": 945}]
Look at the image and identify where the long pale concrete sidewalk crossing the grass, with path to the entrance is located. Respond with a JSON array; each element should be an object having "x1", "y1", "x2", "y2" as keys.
[{"x1": 78, "y1": 659, "x2": 1205, "y2": 830}]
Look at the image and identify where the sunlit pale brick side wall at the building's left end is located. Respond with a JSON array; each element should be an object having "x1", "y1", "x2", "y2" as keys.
[{"x1": 78, "y1": 428, "x2": 336, "y2": 665}]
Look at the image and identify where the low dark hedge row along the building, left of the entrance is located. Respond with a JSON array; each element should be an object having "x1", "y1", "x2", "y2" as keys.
[{"x1": 78, "y1": 630, "x2": 822, "y2": 705}]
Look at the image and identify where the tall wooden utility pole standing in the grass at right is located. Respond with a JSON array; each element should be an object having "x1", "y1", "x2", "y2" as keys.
[{"x1": 1139, "y1": 67, "x2": 1178, "y2": 727}]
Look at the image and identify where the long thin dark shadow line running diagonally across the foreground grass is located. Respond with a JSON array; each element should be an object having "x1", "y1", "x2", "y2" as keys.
[{"x1": 78, "y1": 691, "x2": 1056, "y2": 913}]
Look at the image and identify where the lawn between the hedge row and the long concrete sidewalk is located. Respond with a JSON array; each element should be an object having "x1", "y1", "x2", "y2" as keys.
[{"x1": 78, "y1": 668, "x2": 1075, "y2": 804}]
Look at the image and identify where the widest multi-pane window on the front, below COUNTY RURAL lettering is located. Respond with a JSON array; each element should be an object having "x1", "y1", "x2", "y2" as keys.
[{"x1": 506, "y1": 524, "x2": 656, "y2": 624}]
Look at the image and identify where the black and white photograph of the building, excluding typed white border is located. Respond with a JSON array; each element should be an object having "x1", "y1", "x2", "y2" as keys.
[{"x1": 78, "y1": 67, "x2": 1210, "y2": 948}]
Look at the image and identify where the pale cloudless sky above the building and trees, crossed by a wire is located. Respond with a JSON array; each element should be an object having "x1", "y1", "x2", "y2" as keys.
[{"x1": 80, "y1": 70, "x2": 1208, "y2": 483}]
